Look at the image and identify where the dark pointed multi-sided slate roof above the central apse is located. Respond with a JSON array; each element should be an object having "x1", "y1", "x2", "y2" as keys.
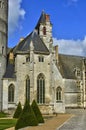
[{"x1": 13, "y1": 30, "x2": 49, "y2": 54}]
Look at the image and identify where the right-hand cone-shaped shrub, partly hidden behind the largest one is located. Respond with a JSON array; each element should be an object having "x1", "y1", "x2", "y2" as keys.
[{"x1": 31, "y1": 100, "x2": 44, "y2": 123}]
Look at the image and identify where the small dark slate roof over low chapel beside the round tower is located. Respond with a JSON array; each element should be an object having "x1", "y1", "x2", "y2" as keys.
[{"x1": 3, "y1": 61, "x2": 16, "y2": 78}]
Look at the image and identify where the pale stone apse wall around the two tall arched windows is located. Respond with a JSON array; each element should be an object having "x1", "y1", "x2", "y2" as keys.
[{"x1": 15, "y1": 51, "x2": 51, "y2": 104}]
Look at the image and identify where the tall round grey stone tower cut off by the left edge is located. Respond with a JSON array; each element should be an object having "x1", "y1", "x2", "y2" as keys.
[{"x1": 0, "y1": 0, "x2": 8, "y2": 110}]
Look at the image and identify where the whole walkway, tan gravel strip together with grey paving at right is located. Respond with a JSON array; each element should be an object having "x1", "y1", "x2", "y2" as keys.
[{"x1": 8, "y1": 109, "x2": 86, "y2": 130}]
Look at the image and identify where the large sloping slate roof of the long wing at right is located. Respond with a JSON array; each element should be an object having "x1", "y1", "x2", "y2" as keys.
[{"x1": 59, "y1": 54, "x2": 83, "y2": 79}]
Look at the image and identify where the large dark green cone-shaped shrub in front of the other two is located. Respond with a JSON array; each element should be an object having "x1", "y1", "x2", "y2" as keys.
[{"x1": 15, "y1": 100, "x2": 38, "y2": 130}]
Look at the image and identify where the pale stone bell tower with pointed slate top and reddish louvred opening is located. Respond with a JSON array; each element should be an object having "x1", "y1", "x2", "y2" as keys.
[{"x1": 36, "y1": 11, "x2": 53, "y2": 49}]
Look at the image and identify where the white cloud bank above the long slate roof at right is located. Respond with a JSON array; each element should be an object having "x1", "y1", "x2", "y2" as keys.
[{"x1": 53, "y1": 37, "x2": 86, "y2": 56}]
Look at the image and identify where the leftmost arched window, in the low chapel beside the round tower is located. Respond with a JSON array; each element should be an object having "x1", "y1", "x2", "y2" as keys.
[{"x1": 8, "y1": 84, "x2": 14, "y2": 102}]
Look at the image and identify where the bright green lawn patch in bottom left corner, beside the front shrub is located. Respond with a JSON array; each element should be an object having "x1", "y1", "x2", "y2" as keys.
[{"x1": 0, "y1": 119, "x2": 17, "y2": 130}]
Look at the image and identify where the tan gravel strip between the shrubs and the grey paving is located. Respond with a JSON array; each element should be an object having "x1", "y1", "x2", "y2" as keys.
[{"x1": 7, "y1": 114, "x2": 72, "y2": 130}]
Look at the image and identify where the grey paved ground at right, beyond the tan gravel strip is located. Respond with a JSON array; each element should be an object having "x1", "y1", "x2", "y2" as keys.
[{"x1": 56, "y1": 109, "x2": 86, "y2": 130}]
